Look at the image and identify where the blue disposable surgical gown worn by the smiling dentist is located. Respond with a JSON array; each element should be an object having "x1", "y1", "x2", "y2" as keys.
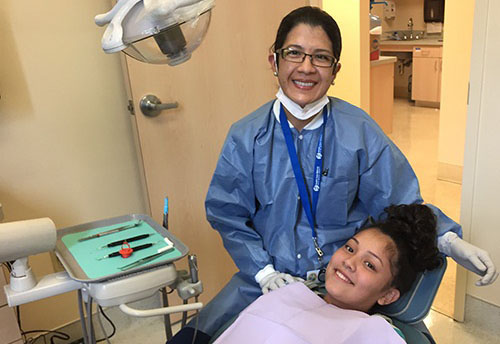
[{"x1": 190, "y1": 98, "x2": 461, "y2": 335}]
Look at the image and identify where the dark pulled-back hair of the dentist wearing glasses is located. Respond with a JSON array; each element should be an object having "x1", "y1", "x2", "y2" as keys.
[{"x1": 271, "y1": 6, "x2": 342, "y2": 63}]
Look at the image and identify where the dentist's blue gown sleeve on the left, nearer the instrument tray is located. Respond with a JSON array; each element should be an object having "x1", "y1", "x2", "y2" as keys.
[{"x1": 205, "y1": 130, "x2": 272, "y2": 277}]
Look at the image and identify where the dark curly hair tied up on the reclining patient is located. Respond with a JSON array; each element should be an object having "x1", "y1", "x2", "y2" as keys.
[{"x1": 365, "y1": 204, "x2": 440, "y2": 294}]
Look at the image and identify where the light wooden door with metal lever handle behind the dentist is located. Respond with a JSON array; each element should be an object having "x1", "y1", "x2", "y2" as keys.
[{"x1": 126, "y1": 0, "x2": 309, "y2": 302}]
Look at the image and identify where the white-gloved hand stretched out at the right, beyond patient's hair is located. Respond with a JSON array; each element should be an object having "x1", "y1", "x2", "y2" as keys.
[{"x1": 438, "y1": 232, "x2": 498, "y2": 287}]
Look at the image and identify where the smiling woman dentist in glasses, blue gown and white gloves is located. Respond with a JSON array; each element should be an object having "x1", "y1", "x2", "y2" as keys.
[{"x1": 170, "y1": 6, "x2": 498, "y2": 343}]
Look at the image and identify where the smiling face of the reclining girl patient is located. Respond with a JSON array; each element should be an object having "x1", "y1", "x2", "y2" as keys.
[{"x1": 325, "y1": 228, "x2": 399, "y2": 312}]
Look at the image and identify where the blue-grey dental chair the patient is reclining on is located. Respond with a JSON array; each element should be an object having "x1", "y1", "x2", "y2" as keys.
[{"x1": 210, "y1": 255, "x2": 447, "y2": 344}]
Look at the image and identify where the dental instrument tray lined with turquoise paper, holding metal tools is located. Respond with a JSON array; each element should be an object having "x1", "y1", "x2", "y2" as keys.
[{"x1": 55, "y1": 214, "x2": 189, "y2": 283}]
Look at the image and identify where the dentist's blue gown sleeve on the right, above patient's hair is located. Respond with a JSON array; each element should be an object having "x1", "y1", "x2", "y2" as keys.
[{"x1": 358, "y1": 126, "x2": 462, "y2": 237}]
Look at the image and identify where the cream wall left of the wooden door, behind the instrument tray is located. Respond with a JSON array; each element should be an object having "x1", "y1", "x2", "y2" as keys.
[{"x1": 0, "y1": 0, "x2": 145, "y2": 330}]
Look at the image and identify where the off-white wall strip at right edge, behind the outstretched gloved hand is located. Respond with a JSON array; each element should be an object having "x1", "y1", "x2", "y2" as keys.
[{"x1": 461, "y1": 0, "x2": 500, "y2": 306}]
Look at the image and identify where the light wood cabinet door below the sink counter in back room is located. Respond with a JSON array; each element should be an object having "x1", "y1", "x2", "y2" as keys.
[{"x1": 411, "y1": 46, "x2": 443, "y2": 103}]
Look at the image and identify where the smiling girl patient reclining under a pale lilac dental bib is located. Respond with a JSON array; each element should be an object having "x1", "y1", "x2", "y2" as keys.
[{"x1": 215, "y1": 204, "x2": 439, "y2": 344}]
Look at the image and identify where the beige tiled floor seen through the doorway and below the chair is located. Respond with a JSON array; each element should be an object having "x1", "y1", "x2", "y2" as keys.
[{"x1": 106, "y1": 99, "x2": 499, "y2": 344}]
